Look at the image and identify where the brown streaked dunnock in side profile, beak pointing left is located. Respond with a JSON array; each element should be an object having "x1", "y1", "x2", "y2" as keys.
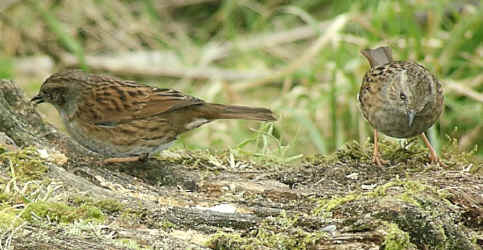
[{"x1": 32, "y1": 70, "x2": 275, "y2": 163}]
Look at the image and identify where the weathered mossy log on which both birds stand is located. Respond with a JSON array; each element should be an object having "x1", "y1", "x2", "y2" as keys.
[{"x1": 0, "y1": 80, "x2": 483, "y2": 249}]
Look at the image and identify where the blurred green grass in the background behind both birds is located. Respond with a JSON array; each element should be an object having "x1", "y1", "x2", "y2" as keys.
[{"x1": 0, "y1": 0, "x2": 483, "y2": 160}]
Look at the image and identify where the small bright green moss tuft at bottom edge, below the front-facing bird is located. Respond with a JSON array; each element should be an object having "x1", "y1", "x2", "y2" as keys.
[{"x1": 384, "y1": 222, "x2": 417, "y2": 250}]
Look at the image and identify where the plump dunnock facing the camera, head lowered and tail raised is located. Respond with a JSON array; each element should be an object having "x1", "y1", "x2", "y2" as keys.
[{"x1": 358, "y1": 47, "x2": 443, "y2": 166}]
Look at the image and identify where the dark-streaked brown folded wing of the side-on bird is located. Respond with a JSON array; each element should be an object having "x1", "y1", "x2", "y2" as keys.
[{"x1": 76, "y1": 79, "x2": 204, "y2": 126}]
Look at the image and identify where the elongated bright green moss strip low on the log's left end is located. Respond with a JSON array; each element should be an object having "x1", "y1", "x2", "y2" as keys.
[{"x1": 22, "y1": 201, "x2": 105, "y2": 223}]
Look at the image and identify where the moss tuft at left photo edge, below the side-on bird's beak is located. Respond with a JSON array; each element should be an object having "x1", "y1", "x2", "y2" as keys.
[{"x1": 0, "y1": 147, "x2": 48, "y2": 181}]
